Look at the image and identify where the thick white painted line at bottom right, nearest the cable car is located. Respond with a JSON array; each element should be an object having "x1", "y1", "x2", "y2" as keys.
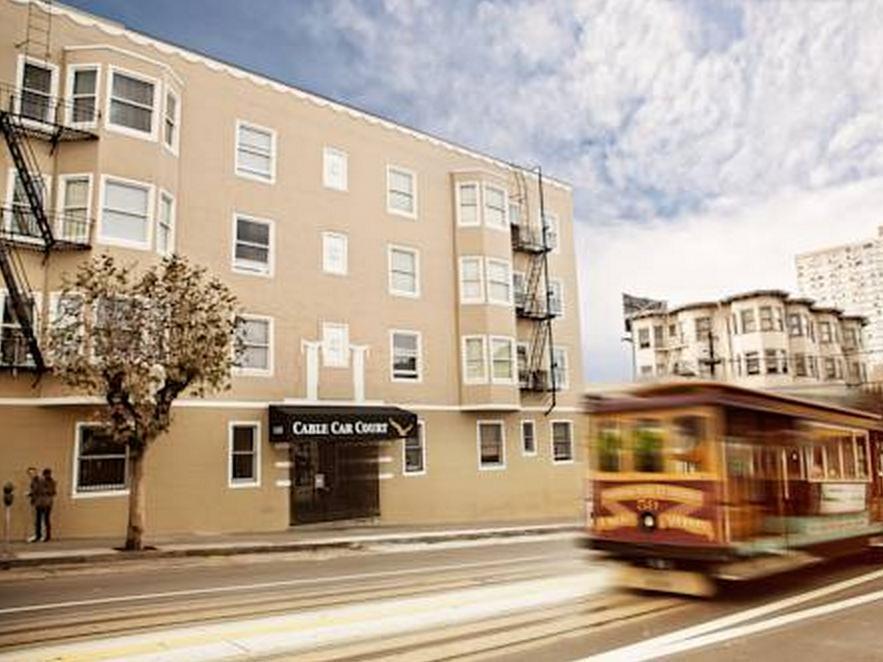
[{"x1": 582, "y1": 570, "x2": 883, "y2": 662}]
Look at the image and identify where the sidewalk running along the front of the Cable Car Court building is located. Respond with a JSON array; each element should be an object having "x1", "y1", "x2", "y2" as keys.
[{"x1": 0, "y1": 520, "x2": 582, "y2": 569}]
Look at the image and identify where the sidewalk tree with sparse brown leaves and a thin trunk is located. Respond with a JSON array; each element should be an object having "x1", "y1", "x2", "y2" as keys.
[{"x1": 50, "y1": 255, "x2": 238, "y2": 550}]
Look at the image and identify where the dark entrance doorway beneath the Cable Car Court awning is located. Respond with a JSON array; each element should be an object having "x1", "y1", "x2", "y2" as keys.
[{"x1": 289, "y1": 439, "x2": 380, "y2": 524}]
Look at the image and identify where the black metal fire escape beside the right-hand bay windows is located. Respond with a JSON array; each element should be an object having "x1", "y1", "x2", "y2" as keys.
[{"x1": 510, "y1": 168, "x2": 560, "y2": 410}]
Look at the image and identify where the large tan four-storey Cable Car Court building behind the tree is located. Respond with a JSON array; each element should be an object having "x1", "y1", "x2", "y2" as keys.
[{"x1": 0, "y1": 0, "x2": 585, "y2": 537}]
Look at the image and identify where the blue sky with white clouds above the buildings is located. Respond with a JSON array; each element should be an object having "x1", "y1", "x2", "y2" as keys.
[{"x1": 68, "y1": 0, "x2": 883, "y2": 381}]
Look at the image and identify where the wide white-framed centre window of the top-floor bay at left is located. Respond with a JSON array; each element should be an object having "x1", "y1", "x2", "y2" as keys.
[{"x1": 105, "y1": 66, "x2": 160, "y2": 140}]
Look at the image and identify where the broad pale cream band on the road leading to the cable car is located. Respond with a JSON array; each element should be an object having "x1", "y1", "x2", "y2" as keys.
[{"x1": 0, "y1": 569, "x2": 607, "y2": 662}]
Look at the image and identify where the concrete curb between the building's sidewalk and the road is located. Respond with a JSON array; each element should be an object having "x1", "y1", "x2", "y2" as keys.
[{"x1": 0, "y1": 524, "x2": 582, "y2": 570}]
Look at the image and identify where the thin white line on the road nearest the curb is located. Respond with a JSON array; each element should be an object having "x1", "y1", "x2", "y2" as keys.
[{"x1": 0, "y1": 554, "x2": 563, "y2": 615}]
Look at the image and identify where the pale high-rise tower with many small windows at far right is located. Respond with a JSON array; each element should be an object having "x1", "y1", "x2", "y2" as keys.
[{"x1": 796, "y1": 227, "x2": 883, "y2": 373}]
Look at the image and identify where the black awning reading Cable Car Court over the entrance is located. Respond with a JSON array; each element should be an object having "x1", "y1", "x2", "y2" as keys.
[{"x1": 270, "y1": 405, "x2": 417, "y2": 443}]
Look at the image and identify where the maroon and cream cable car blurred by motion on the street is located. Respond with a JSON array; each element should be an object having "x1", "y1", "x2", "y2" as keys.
[{"x1": 586, "y1": 381, "x2": 883, "y2": 596}]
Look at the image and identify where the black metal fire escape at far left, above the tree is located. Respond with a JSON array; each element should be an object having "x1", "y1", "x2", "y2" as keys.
[{"x1": 0, "y1": 80, "x2": 97, "y2": 375}]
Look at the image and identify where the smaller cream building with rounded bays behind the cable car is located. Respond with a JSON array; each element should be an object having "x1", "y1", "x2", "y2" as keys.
[{"x1": 630, "y1": 290, "x2": 868, "y2": 388}]
